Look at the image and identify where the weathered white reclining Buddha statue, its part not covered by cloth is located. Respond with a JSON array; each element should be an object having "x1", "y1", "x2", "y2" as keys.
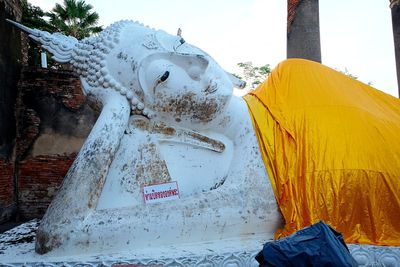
[{"x1": 7, "y1": 21, "x2": 281, "y2": 254}]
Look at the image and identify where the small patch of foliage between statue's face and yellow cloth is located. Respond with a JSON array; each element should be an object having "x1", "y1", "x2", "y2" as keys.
[{"x1": 234, "y1": 61, "x2": 271, "y2": 89}]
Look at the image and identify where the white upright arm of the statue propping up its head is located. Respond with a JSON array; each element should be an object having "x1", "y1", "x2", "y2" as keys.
[{"x1": 36, "y1": 89, "x2": 130, "y2": 253}]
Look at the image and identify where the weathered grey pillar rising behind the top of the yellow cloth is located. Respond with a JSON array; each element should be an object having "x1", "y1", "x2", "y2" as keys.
[{"x1": 287, "y1": 0, "x2": 321, "y2": 62}]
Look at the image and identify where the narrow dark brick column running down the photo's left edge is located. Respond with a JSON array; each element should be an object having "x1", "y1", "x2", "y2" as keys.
[{"x1": 0, "y1": 0, "x2": 22, "y2": 223}]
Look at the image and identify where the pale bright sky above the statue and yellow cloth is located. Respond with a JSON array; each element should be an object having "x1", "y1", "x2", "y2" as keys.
[{"x1": 29, "y1": 0, "x2": 398, "y2": 96}]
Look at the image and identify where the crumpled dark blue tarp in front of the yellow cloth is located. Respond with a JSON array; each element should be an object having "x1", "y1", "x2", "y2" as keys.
[{"x1": 256, "y1": 221, "x2": 358, "y2": 267}]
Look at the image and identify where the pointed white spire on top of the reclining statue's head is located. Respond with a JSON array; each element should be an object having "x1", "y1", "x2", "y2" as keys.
[{"x1": 6, "y1": 19, "x2": 79, "y2": 63}]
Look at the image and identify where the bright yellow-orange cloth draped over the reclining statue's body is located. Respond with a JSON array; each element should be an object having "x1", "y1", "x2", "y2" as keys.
[{"x1": 244, "y1": 59, "x2": 400, "y2": 246}]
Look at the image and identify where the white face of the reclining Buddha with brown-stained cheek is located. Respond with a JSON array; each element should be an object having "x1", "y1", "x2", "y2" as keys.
[{"x1": 139, "y1": 33, "x2": 233, "y2": 125}]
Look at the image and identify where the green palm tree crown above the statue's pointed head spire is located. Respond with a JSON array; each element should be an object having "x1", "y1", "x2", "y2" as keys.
[{"x1": 47, "y1": 0, "x2": 102, "y2": 39}]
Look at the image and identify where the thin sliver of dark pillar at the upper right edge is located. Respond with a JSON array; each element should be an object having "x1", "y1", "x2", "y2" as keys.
[{"x1": 390, "y1": 0, "x2": 400, "y2": 97}]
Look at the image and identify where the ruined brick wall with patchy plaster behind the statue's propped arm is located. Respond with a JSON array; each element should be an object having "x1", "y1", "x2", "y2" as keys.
[{"x1": 15, "y1": 67, "x2": 98, "y2": 220}]
